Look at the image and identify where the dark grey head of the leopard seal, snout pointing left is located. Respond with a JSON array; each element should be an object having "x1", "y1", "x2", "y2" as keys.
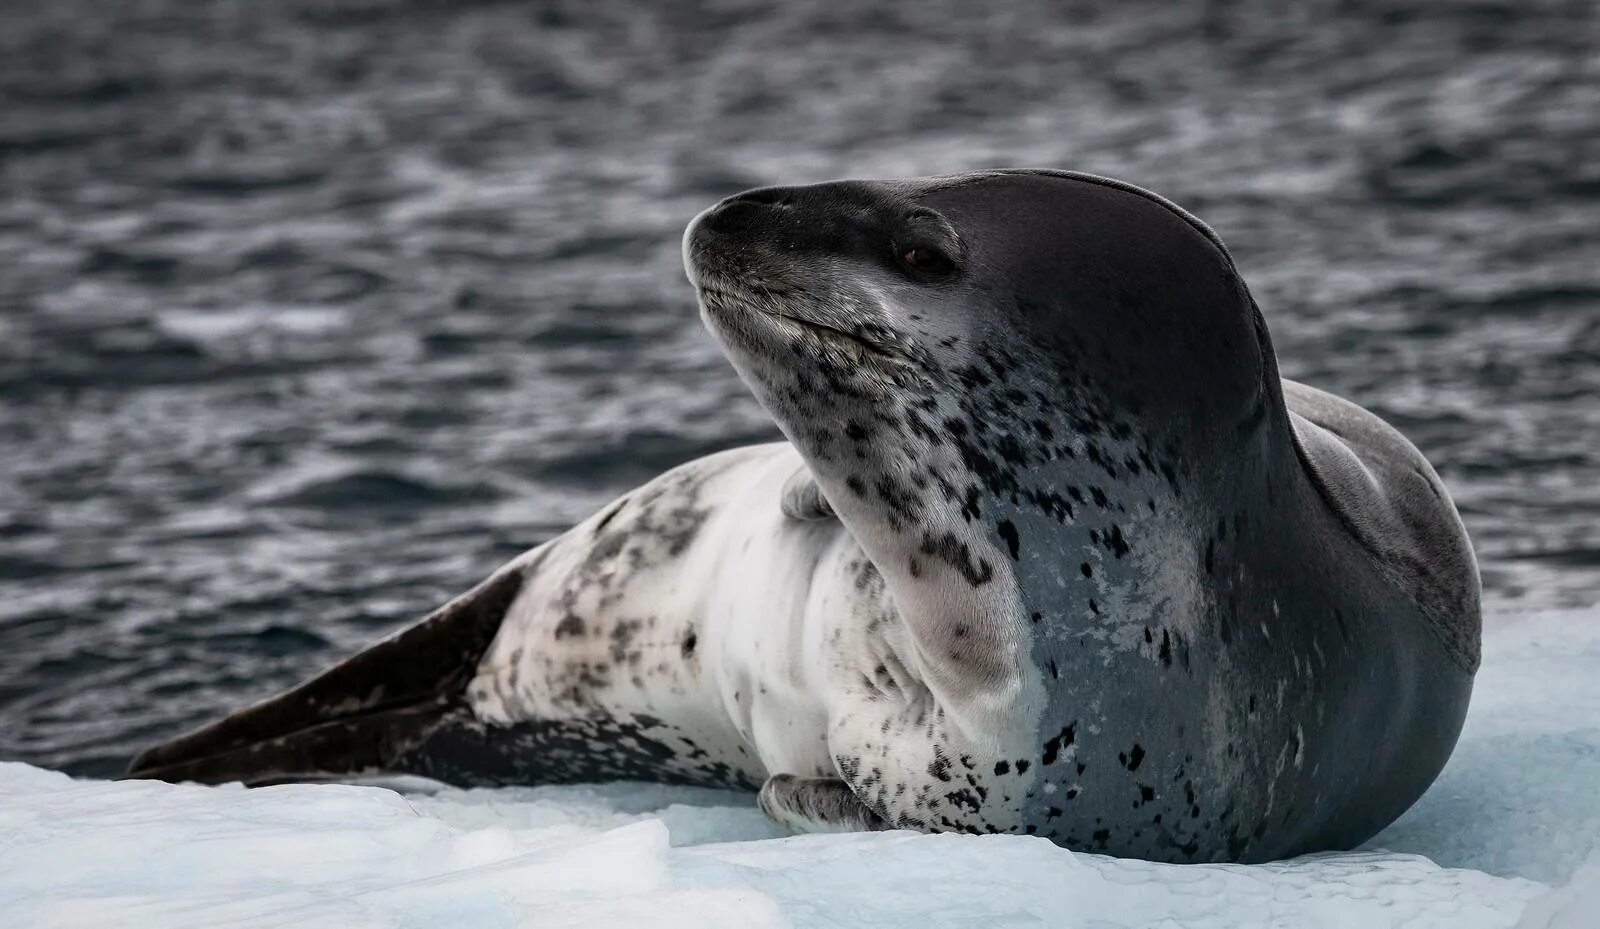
[{"x1": 685, "y1": 171, "x2": 1272, "y2": 463}]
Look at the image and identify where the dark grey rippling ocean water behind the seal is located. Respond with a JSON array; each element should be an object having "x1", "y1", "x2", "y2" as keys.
[{"x1": 0, "y1": 0, "x2": 1600, "y2": 774}]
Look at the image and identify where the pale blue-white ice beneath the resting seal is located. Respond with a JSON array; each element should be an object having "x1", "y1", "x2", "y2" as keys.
[{"x1": 0, "y1": 608, "x2": 1600, "y2": 929}]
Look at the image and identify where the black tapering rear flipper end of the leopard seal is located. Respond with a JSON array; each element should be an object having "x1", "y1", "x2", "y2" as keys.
[{"x1": 126, "y1": 569, "x2": 523, "y2": 785}]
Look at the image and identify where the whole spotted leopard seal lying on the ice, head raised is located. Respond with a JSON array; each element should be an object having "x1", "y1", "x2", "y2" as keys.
[{"x1": 130, "y1": 171, "x2": 1482, "y2": 862}]
